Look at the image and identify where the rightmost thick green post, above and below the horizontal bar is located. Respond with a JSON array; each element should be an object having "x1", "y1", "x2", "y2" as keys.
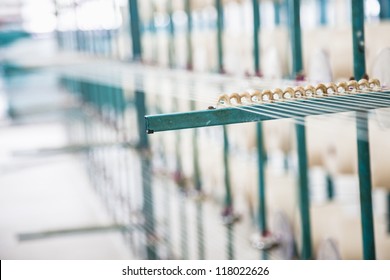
[{"x1": 351, "y1": 0, "x2": 375, "y2": 260}]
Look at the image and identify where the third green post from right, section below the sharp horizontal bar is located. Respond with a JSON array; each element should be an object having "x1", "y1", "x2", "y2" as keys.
[{"x1": 256, "y1": 122, "x2": 268, "y2": 236}]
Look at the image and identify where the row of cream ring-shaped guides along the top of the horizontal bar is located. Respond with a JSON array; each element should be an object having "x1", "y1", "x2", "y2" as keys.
[{"x1": 217, "y1": 79, "x2": 382, "y2": 106}]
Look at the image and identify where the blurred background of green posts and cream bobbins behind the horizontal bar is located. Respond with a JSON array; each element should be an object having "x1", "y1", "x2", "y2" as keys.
[{"x1": 0, "y1": 0, "x2": 390, "y2": 259}]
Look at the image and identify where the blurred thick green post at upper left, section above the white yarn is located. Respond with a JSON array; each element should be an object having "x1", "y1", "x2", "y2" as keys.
[{"x1": 129, "y1": 0, "x2": 142, "y2": 61}]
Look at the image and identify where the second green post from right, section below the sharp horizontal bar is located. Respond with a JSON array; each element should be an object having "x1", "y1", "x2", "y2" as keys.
[{"x1": 295, "y1": 119, "x2": 312, "y2": 260}]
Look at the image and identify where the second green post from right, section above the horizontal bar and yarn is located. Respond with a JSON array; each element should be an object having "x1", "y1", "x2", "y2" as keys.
[{"x1": 288, "y1": 0, "x2": 303, "y2": 78}]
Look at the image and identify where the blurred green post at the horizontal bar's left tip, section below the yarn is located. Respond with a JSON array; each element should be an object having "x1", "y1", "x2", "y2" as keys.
[{"x1": 135, "y1": 86, "x2": 157, "y2": 260}]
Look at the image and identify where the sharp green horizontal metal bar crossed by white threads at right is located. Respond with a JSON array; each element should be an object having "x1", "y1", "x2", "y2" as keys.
[{"x1": 145, "y1": 92, "x2": 390, "y2": 134}]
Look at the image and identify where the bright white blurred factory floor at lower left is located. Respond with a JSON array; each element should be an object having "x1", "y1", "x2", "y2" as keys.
[{"x1": 0, "y1": 122, "x2": 132, "y2": 259}]
